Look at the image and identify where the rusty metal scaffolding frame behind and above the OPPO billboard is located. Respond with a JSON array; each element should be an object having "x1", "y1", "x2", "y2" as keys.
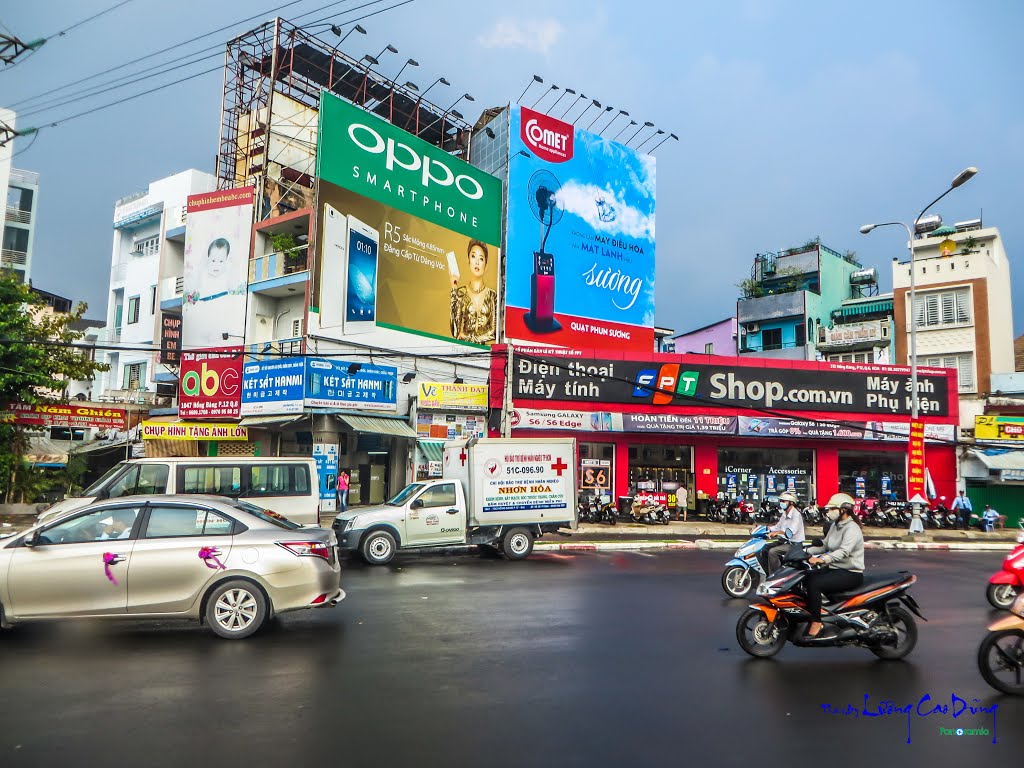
[{"x1": 217, "y1": 18, "x2": 470, "y2": 220}]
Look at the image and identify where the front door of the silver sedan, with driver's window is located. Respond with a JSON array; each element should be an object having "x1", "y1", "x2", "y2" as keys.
[{"x1": 7, "y1": 505, "x2": 142, "y2": 618}]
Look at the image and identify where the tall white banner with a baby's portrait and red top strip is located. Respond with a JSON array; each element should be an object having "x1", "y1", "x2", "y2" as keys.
[{"x1": 181, "y1": 186, "x2": 253, "y2": 349}]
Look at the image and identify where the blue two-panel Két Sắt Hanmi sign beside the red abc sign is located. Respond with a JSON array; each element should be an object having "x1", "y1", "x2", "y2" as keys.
[{"x1": 242, "y1": 357, "x2": 398, "y2": 416}]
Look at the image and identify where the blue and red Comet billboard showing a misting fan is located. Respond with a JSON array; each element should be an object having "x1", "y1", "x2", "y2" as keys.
[{"x1": 505, "y1": 106, "x2": 655, "y2": 351}]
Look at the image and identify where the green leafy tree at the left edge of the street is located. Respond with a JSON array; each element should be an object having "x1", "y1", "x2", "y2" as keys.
[{"x1": 0, "y1": 274, "x2": 108, "y2": 501}]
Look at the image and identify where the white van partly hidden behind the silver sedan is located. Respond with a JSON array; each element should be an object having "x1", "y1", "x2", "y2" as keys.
[{"x1": 37, "y1": 456, "x2": 319, "y2": 525}]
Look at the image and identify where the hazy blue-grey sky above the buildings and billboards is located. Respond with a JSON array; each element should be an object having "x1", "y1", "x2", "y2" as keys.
[{"x1": 0, "y1": 0, "x2": 1024, "y2": 333}]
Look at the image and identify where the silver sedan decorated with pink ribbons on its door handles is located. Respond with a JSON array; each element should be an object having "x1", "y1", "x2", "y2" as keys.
[{"x1": 0, "y1": 496, "x2": 345, "y2": 638}]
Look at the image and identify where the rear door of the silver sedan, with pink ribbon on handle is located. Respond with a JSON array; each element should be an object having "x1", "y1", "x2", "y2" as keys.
[{"x1": 128, "y1": 504, "x2": 236, "y2": 613}]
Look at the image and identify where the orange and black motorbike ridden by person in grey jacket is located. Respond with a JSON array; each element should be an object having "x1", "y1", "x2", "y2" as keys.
[{"x1": 736, "y1": 544, "x2": 927, "y2": 658}]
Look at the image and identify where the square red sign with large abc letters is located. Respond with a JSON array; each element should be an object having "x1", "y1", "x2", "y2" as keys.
[{"x1": 178, "y1": 348, "x2": 243, "y2": 419}]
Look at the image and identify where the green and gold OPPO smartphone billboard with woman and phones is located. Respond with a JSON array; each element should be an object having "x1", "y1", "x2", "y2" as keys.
[{"x1": 311, "y1": 92, "x2": 502, "y2": 346}]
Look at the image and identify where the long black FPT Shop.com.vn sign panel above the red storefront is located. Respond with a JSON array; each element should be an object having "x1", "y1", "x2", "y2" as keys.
[{"x1": 512, "y1": 355, "x2": 949, "y2": 416}]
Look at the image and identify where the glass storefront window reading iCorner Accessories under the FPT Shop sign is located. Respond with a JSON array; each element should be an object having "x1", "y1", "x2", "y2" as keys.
[{"x1": 718, "y1": 449, "x2": 814, "y2": 504}]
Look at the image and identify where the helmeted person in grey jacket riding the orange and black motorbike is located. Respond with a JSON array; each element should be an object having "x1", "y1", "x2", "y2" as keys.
[{"x1": 804, "y1": 494, "x2": 864, "y2": 637}]
